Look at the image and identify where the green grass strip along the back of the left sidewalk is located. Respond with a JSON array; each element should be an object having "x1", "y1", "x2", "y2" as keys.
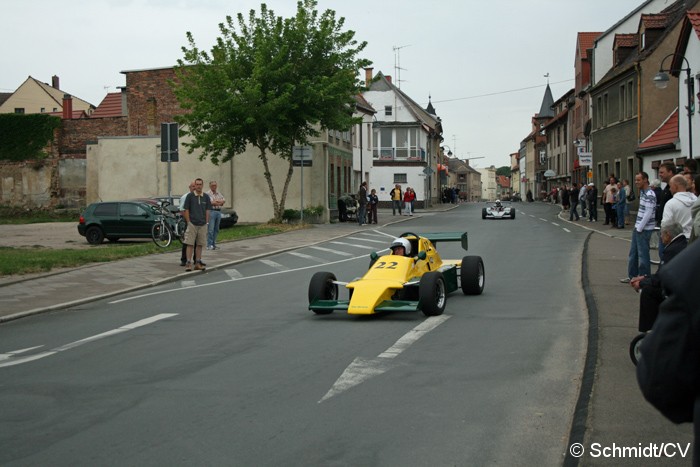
[{"x1": 0, "y1": 224, "x2": 304, "y2": 276}]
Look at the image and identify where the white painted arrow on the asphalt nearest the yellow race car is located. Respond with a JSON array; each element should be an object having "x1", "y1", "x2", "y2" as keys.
[{"x1": 318, "y1": 315, "x2": 450, "y2": 404}]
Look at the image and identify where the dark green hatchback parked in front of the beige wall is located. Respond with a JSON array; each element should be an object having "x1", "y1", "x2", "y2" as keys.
[{"x1": 78, "y1": 200, "x2": 159, "y2": 245}]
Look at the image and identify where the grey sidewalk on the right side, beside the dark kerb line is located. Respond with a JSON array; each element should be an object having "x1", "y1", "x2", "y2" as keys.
[{"x1": 559, "y1": 207, "x2": 693, "y2": 467}]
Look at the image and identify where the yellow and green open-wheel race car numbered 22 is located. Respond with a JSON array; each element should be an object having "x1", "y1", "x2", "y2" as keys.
[{"x1": 309, "y1": 232, "x2": 486, "y2": 316}]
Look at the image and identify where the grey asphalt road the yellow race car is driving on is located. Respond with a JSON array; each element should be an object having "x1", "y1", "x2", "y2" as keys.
[{"x1": 0, "y1": 204, "x2": 588, "y2": 466}]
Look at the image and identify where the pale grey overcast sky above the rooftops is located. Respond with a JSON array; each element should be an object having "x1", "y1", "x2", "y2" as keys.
[{"x1": 0, "y1": 0, "x2": 656, "y2": 167}]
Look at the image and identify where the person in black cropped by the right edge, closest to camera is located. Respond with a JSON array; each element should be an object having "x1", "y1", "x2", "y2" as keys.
[{"x1": 637, "y1": 242, "x2": 700, "y2": 466}]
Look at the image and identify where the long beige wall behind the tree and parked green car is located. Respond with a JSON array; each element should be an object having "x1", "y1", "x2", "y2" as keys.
[{"x1": 86, "y1": 136, "x2": 328, "y2": 222}]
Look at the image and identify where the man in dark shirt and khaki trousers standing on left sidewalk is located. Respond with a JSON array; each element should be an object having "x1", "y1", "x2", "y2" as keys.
[{"x1": 184, "y1": 178, "x2": 211, "y2": 271}]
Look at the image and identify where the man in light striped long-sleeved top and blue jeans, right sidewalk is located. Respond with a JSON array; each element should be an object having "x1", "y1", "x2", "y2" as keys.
[{"x1": 620, "y1": 172, "x2": 656, "y2": 283}]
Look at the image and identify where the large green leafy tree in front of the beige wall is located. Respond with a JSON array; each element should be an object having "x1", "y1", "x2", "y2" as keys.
[{"x1": 172, "y1": 0, "x2": 371, "y2": 220}]
